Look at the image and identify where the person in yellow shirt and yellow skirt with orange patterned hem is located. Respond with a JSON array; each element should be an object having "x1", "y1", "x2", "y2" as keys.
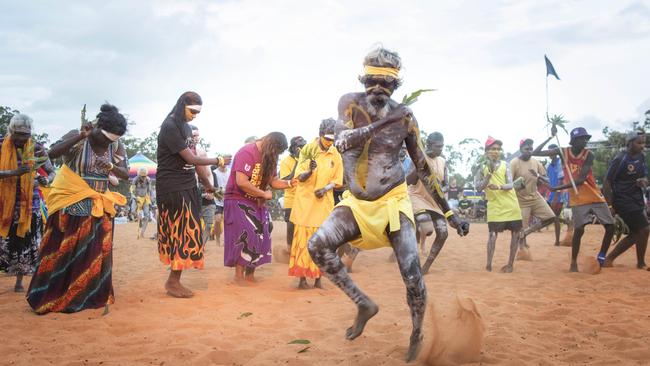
[{"x1": 289, "y1": 118, "x2": 343, "y2": 289}]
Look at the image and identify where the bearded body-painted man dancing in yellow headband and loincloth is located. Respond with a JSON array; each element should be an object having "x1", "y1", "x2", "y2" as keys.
[{"x1": 309, "y1": 48, "x2": 469, "y2": 361}]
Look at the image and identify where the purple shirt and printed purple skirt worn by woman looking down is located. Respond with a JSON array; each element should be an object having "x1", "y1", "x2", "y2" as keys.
[{"x1": 223, "y1": 143, "x2": 271, "y2": 268}]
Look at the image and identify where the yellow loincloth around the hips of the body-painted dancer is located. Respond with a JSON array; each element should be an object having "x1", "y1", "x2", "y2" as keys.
[{"x1": 337, "y1": 183, "x2": 415, "y2": 250}]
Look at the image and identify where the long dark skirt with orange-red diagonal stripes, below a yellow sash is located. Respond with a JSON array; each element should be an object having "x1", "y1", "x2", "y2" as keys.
[{"x1": 27, "y1": 211, "x2": 114, "y2": 314}]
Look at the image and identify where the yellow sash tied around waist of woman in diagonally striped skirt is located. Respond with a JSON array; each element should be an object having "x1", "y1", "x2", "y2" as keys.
[{"x1": 47, "y1": 164, "x2": 126, "y2": 217}]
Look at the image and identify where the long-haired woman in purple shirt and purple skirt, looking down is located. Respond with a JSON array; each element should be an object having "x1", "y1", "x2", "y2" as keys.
[{"x1": 223, "y1": 132, "x2": 295, "y2": 282}]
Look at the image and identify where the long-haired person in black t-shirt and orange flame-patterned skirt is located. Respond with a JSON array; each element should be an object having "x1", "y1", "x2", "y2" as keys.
[{"x1": 156, "y1": 92, "x2": 229, "y2": 298}]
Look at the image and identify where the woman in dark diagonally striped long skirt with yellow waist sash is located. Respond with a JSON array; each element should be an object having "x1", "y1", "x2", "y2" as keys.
[{"x1": 27, "y1": 104, "x2": 129, "y2": 314}]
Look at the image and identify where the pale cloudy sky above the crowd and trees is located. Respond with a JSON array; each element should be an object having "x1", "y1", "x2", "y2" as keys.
[{"x1": 0, "y1": 0, "x2": 650, "y2": 159}]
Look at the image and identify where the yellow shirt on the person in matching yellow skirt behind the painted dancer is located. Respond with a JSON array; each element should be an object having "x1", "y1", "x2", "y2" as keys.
[{"x1": 285, "y1": 139, "x2": 343, "y2": 227}]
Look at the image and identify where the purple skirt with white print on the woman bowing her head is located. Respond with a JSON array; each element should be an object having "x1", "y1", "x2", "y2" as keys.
[{"x1": 223, "y1": 199, "x2": 271, "y2": 268}]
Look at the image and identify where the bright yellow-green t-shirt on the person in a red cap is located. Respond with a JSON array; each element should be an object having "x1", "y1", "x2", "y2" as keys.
[{"x1": 483, "y1": 161, "x2": 521, "y2": 222}]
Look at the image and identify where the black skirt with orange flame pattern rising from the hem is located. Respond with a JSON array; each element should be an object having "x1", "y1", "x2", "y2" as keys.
[{"x1": 156, "y1": 188, "x2": 203, "y2": 271}]
